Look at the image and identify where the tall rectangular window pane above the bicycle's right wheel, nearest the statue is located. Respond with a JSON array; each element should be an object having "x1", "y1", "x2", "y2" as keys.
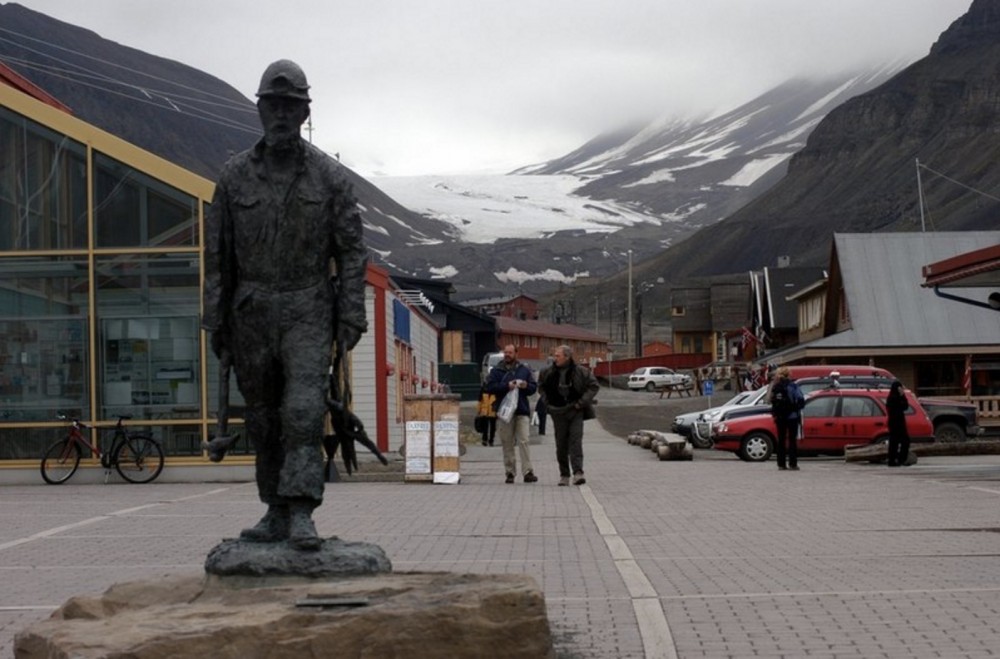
[{"x1": 96, "y1": 253, "x2": 201, "y2": 420}]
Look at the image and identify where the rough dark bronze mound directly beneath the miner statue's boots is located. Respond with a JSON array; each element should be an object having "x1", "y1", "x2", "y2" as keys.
[{"x1": 205, "y1": 537, "x2": 392, "y2": 578}]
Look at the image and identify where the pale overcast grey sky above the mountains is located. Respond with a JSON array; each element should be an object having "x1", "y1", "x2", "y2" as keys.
[{"x1": 9, "y1": 0, "x2": 972, "y2": 175}]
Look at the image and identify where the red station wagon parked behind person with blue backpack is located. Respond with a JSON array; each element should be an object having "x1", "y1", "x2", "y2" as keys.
[{"x1": 715, "y1": 389, "x2": 934, "y2": 462}]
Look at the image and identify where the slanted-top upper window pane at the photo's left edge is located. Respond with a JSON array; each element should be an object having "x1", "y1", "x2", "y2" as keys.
[{"x1": 0, "y1": 108, "x2": 87, "y2": 251}]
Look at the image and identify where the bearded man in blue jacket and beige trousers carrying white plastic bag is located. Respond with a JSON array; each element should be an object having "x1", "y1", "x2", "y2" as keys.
[{"x1": 486, "y1": 345, "x2": 538, "y2": 483}]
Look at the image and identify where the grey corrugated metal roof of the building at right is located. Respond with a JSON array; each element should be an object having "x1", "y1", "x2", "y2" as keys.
[{"x1": 809, "y1": 231, "x2": 1000, "y2": 348}]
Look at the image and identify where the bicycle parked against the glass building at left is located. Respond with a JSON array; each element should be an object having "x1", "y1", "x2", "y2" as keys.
[{"x1": 41, "y1": 414, "x2": 163, "y2": 485}]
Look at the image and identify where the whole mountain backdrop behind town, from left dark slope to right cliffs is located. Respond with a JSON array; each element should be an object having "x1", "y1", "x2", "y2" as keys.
[{"x1": 0, "y1": 0, "x2": 1000, "y2": 320}]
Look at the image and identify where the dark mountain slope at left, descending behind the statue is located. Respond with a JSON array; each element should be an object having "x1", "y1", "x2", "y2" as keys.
[{"x1": 0, "y1": 3, "x2": 453, "y2": 252}]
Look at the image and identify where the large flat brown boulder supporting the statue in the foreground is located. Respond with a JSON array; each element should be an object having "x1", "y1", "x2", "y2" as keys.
[{"x1": 14, "y1": 573, "x2": 554, "y2": 659}]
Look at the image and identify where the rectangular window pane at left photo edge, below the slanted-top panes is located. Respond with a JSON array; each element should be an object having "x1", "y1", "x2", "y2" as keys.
[{"x1": 0, "y1": 257, "x2": 90, "y2": 426}]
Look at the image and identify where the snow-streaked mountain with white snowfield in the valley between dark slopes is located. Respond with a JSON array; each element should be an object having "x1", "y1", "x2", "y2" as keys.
[{"x1": 372, "y1": 63, "x2": 903, "y2": 293}]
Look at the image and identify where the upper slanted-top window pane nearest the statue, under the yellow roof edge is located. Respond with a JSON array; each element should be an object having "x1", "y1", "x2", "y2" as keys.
[{"x1": 94, "y1": 153, "x2": 198, "y2": 247}]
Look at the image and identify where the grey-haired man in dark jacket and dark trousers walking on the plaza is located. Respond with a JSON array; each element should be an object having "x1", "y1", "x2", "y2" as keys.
[{"x1": 538, "y1": 346, "x2": 601, "y2": 485}]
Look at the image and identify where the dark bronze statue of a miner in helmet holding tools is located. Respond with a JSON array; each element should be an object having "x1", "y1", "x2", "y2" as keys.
[{"x1": 203, "y1": 60, "x2": 381, "y2": 550}]
